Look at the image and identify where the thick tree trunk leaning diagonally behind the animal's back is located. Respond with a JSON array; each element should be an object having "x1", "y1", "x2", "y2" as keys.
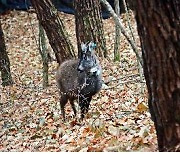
[{"x1": 31, "y1": 0, "x2": 75, "y2": 64}]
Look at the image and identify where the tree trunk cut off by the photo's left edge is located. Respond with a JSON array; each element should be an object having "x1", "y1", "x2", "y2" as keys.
[{"x1": 0, "y1": 21, "x2": 13, "y2": 86}]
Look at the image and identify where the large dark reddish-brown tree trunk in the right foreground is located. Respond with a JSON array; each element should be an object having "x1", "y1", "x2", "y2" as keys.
[{"x1": 135, "y1": 0, "x2": 180, "y2": 151}]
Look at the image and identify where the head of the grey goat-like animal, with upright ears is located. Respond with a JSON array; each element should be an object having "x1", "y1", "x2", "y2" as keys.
[{"x1": 78, "y1": 42, "x2": 99, "y2": 72}]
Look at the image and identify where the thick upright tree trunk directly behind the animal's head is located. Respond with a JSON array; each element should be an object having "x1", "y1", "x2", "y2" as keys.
[{"x1": 74, "y1": 0, "x2": 107, "y2": 57}]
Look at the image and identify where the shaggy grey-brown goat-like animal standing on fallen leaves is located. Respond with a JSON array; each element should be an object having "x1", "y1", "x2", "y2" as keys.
[{"x1": 56, "y1": 42, "x2": 102, "y2": 120}]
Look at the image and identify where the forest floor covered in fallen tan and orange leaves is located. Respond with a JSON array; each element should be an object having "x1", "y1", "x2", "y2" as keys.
[{"x1": 0, "y1": 11, "x2": 157, "y2": 152}]
